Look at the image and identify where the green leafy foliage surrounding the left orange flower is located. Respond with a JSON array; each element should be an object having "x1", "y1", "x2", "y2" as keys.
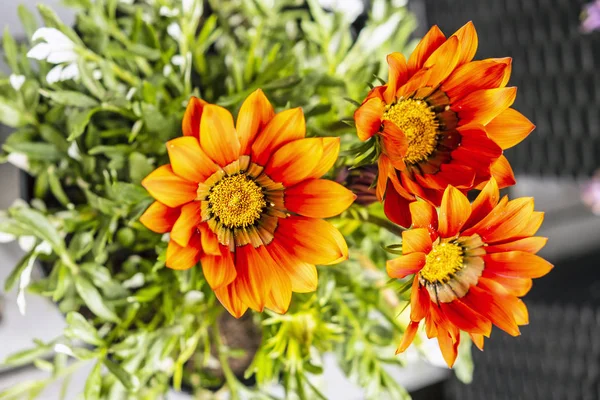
[{"x1": 0, "y1": 0, "x2": 468, "y2": 400}]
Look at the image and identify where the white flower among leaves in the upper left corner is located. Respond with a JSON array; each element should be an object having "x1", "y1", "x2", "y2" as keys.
[{"x1": 27, "y1": 27, "x2": 79, "y2": 84}]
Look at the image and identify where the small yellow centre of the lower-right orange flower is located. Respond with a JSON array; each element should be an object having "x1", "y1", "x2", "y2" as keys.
[{"x1": 419, "y1": 242, "x2": 463, "y2": 282}]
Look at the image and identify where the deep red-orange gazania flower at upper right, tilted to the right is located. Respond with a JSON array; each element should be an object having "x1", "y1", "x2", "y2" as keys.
[{"x1": 354, "y1": 22, "x2": 534, "y2": 227}]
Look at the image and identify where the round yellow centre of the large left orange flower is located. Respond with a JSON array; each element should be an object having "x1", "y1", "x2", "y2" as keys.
[{"x1": 208, "y1": 174, "x2": 267, "y2": 228}]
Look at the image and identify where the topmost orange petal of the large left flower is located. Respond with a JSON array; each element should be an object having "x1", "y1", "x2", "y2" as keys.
[{"x1": 235, "y1": 89, "x2": 275, "y2": 155}]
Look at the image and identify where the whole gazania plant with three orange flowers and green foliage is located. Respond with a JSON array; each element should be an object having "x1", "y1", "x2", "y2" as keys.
[{"x1": 0, "y1": 0, "x2": 552, "y2": 400}]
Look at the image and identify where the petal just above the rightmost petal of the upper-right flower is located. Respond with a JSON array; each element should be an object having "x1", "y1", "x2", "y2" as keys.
[{"x1": 451, "y1": 87, "x2": 517, "y2": 125}]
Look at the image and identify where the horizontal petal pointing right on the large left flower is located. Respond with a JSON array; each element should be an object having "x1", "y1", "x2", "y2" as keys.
[{"x1": 284, "y1": 179, "x2": 356, "y2": 218}]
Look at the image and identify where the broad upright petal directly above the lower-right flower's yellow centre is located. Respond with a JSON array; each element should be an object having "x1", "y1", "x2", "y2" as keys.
[{"x1": 438, "y1": 186, "x2": 471, "y2": 238}]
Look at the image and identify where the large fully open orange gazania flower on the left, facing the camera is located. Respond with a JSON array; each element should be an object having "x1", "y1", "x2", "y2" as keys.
[{"x1": 140, "y1": 90, "x2": 355, "y2": 317}]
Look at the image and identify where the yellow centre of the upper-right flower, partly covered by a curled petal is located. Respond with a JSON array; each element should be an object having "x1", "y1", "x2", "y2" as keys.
[{"x1": 383, "y1": 99, "x2": 438, "y2": 164}]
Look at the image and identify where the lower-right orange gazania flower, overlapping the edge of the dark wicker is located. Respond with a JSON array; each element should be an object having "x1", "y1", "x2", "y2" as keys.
[{"x1": 387, "y1": 178, "x2": 552, "y2": 367}]
